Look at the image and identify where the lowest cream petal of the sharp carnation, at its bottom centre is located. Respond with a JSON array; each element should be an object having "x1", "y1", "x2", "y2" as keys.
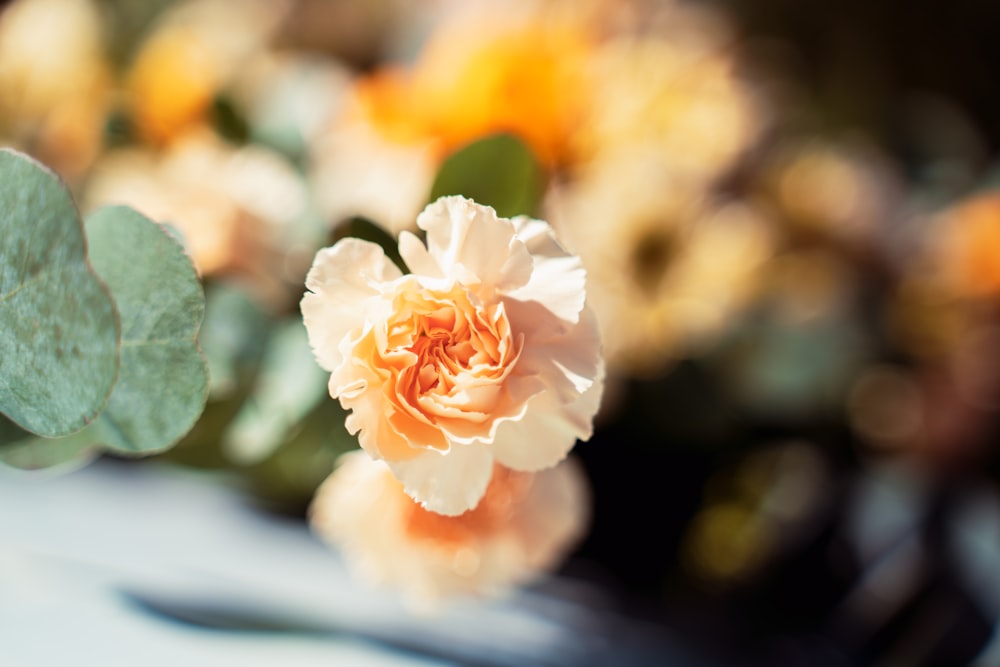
[{"x1": 386, "y1": 444, "x2": 493, "y2": 516}]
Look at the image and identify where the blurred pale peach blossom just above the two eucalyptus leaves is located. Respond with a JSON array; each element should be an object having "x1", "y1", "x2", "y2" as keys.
[{"x1": 85, "y1": 129, "x2": 308, "y2": 301}]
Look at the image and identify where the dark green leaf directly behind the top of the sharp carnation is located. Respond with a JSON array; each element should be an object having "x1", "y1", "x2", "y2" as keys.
[{"x1": 430, "y1": 134, "x2": 545, "y2": 217}]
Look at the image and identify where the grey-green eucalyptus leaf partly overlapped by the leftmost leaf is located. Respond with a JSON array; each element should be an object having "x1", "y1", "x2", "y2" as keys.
[{"x1": 87, "y1": 206, "x2": 208, "y2": 454}]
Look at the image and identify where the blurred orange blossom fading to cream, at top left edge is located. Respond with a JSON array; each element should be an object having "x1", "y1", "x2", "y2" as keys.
[{"x1": 125, "y1": 0, "x2": 288, "y2": 143}]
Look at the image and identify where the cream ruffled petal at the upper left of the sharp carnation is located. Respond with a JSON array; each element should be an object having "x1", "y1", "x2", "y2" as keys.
[{"x1": 300, "y1": 238, "x2": 402, "y2": 371}]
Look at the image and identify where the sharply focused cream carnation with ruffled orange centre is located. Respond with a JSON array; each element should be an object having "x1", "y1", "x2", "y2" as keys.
[{"x1": 302, "y1": 197, "x2": 604, "y2": 515}]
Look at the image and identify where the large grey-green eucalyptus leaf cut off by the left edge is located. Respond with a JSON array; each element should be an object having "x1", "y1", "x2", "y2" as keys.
[{"x1": 0, "y1": 149, "x2": 119, "y2": 436}]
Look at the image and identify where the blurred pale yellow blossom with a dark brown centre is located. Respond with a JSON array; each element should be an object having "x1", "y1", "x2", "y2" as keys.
[{"x1": 549, "y1": 151, "x2": 772, "y2": 374}]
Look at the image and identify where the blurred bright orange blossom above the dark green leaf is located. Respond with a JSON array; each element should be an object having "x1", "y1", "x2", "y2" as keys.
[{"x1": 411, "y1": 4, "x2": 592, "y2": 164}]
